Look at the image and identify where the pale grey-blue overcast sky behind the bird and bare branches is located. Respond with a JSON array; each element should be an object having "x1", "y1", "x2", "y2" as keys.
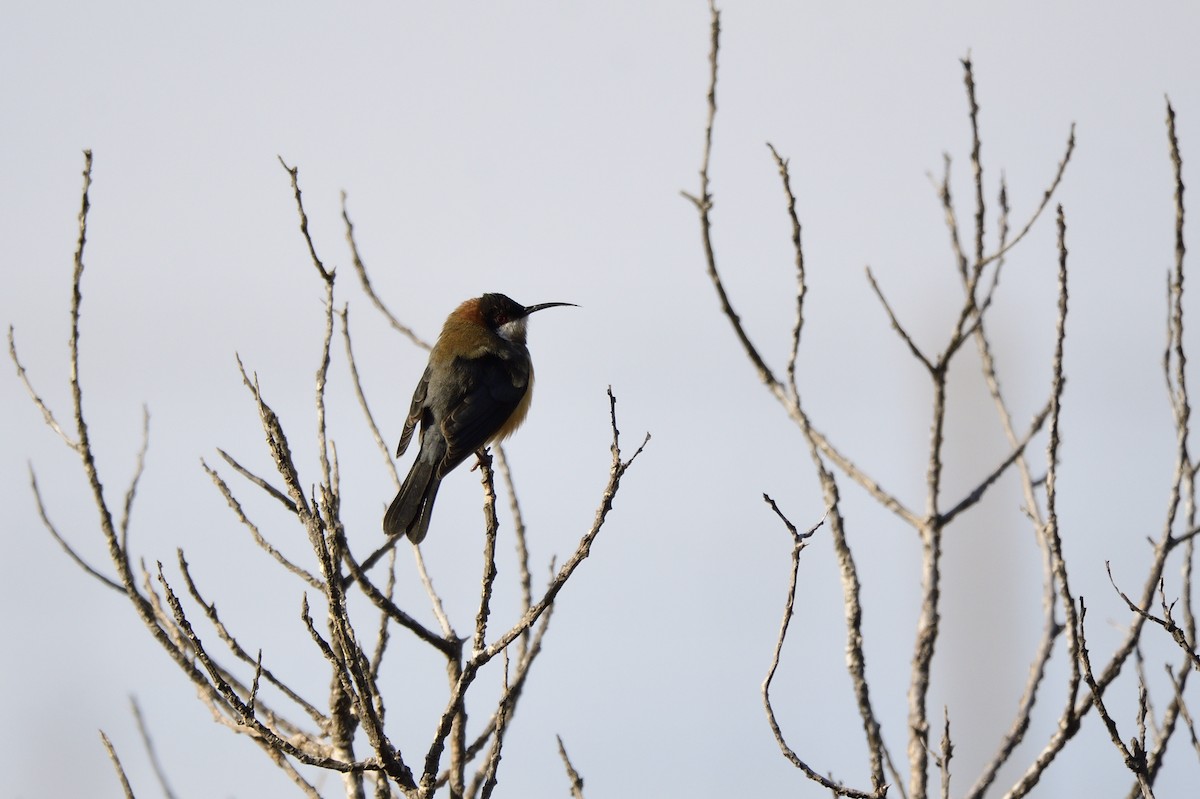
[{"x1": 0, "y1": 0, "x2": 1200, "y2": 798}]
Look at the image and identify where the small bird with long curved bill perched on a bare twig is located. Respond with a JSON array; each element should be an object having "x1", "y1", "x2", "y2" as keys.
[{"x1": 383, "y1": 294, "x2": 575, "y2": 543}]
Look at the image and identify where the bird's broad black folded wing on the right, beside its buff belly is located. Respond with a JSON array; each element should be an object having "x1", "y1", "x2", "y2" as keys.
[{"x1": 438, "y1": 355, "x2": 529, "y2": 474}]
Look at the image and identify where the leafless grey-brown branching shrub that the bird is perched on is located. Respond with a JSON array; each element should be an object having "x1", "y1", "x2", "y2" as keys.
[{"x1": 18, "y1": 133, "x2": 649, "y2": 799}]
